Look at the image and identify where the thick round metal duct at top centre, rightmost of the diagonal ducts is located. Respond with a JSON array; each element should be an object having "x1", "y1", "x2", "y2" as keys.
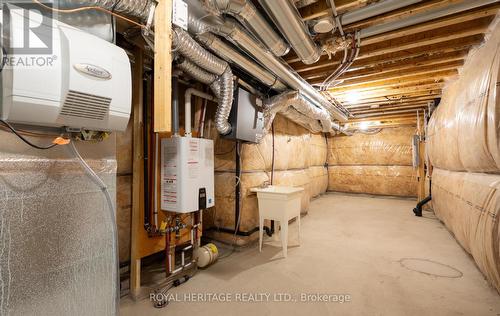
[{"x1": 259, "y1": 0, "x2": 322, "y2": 65}]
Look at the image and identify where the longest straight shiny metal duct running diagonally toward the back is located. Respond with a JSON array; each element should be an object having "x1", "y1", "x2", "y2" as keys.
[{"x1": 212, "y1": 20, "x2": 347, "y2": 122}]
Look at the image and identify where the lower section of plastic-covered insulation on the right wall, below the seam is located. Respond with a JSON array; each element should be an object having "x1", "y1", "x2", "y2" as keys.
[{"x1": 432, "y1": 169, "x2": 500, "y2": 292}]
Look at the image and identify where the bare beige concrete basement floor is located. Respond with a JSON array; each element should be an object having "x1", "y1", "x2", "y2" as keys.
[{"x1": 121, "y1": 194, "x2": 500, "y2": 316}]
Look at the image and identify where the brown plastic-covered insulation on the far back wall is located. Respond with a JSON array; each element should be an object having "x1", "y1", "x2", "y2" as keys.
[{"x1": 328, "y1": 126, "x2": 417, "y2": 196}]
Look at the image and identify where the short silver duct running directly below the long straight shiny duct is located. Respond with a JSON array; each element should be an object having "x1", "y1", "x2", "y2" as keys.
[{"x1": 197, "y1": 33, "x2": 286, "y2": 91}]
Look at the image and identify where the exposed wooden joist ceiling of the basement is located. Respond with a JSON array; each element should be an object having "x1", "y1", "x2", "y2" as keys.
[{"x1": 285, "y1": 0, "x2": 500, "y2": 118}]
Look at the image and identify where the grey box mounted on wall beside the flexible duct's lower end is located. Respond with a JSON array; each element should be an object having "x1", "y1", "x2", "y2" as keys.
[{"x1": 224, "y1": 87, "x2": 264, "y2": 143}]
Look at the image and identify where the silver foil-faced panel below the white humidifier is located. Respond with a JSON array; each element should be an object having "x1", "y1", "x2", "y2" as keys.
[{"x1": 0, "y1": 132, "x2": 118, "y2": 315}]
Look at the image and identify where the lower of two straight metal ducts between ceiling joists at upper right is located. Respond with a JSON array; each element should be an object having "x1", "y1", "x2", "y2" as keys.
[{"x1": 360, "y1": 0, "x2": 498, "y2": 38}]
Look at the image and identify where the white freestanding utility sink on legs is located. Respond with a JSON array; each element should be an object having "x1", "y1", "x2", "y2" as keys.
[{"x1": 250, "y1": 186, "x2": 304, "y2": 257}]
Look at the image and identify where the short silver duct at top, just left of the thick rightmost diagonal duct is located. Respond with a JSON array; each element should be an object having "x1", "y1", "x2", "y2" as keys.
[{"x1": 208, "y1": 0, "x2": 290, "y2": 56}]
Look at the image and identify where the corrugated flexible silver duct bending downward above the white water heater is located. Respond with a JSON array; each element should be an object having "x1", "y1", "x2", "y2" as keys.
[{"x1": 172, "y1": 27, "x2": 234, "y2": 135}]
